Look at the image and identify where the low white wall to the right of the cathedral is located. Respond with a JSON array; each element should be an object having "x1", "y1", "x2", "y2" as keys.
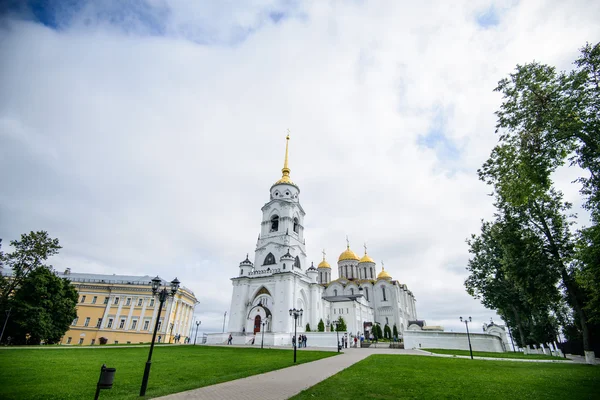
[{"x1": 404, "y1": 331, "x2": 504, "y2": 353}]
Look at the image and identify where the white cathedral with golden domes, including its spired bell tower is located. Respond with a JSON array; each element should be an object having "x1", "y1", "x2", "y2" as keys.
[{"x1": 228, "y1": 135, "x2": 417, "y2": 344}]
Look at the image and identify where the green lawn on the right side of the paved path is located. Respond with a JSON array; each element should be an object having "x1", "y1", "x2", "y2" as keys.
[{"x1": 292, "y1": 355, "x2": 600, "y2": 400}]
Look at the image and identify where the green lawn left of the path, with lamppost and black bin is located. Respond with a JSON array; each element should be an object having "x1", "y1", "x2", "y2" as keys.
[{"x1": 0, "y1": 346, "x2": 337, "y2": 400}]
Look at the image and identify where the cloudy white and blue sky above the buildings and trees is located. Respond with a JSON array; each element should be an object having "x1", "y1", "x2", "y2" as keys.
[{"x1": 0, "y1": 0, "x2": 600, "y2": 332}]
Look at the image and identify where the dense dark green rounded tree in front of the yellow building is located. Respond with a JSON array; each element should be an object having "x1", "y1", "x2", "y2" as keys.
[{"x1": 5, "y1": 267, "x2": 78, "y2": 344}]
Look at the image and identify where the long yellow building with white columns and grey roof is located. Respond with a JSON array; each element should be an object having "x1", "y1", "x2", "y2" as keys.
[{"x1": 57, "y1": 268, "x2": 197, "y2": 345}]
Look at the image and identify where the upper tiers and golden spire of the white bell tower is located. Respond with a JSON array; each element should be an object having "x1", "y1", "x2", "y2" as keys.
[{"x1": 254, "y1": 131, "x2": 308, "y2": 272}]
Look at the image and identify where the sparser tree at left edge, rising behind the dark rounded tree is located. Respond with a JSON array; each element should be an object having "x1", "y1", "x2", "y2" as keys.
[{"x1": 0, "y1": 231, "x2": 61, "y2": 309}]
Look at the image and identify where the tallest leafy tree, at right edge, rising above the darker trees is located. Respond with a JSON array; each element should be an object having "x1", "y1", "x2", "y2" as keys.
[{"x1": 479, "y1": 44, "x2": 600, "y2": 360}]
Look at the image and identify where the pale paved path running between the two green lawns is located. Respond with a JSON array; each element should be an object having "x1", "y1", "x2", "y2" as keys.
[{"x1": 159, "y1": 348, "x2": 424, "y2": 400}]
